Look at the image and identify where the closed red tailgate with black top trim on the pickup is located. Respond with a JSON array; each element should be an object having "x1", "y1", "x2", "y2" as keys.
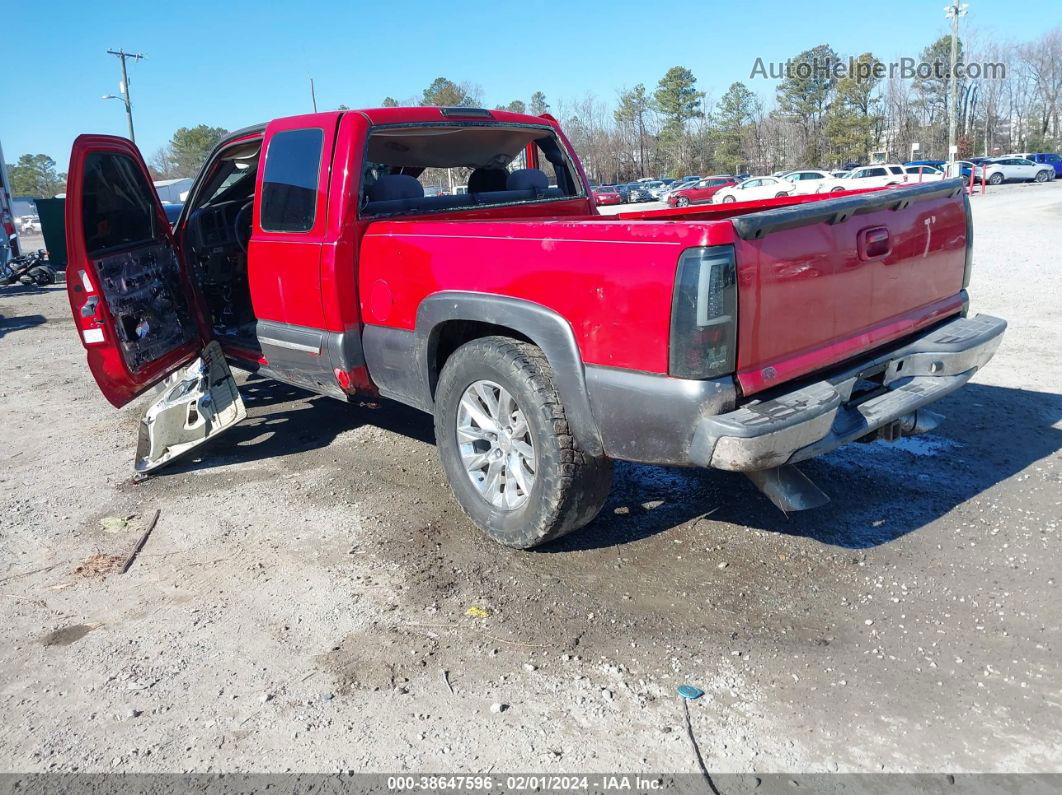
[{"x1": 732, "y1": 179, "x2": 972, "y2": 395}]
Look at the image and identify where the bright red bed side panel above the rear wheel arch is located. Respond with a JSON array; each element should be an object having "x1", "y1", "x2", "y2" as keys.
[{"x1": 359, "y1": 218, "x2": 733, "y2": 373}]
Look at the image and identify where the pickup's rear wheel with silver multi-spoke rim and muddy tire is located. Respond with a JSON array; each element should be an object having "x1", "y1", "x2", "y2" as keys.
[{"x1": 435, "y1": 336, "x2": 612, "y2": 549}]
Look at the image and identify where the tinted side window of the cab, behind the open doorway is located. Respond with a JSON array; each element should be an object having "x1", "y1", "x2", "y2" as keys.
[{"x1": 261, "y1": 128, "x2": 325, "y2": 231}]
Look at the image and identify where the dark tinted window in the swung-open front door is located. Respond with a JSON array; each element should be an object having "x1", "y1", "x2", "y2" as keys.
[{"x1": 81, "y1": 152, "x2": 157, "y2": 257}]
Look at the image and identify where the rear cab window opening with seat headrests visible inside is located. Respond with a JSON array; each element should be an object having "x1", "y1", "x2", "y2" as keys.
[{"x1": 359, "y1": 122, "x2": 586, "y2": 218}]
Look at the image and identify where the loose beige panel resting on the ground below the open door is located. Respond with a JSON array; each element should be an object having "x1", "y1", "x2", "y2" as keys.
[{"x1": 134, "y1": 342, "x2": 247, "y2": 474}]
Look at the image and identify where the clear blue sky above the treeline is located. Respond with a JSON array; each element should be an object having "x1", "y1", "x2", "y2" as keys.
[{"x1": 0, "y1": 0, "x2": 1062, "y2": 171}]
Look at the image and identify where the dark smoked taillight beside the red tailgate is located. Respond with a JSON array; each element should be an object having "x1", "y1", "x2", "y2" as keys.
[{"x1": 668, "y1": 245, "x2": 737, "y2": 378}]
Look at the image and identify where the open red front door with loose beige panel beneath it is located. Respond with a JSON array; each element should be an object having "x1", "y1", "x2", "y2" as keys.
[{"x1": 66, "y1": 135, "x2": 246, "y2": 472}]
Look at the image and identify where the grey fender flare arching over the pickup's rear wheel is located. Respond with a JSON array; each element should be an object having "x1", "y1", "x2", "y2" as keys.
[{"x1": 414, "y1": 290, "x2": 604, "y2": 455}]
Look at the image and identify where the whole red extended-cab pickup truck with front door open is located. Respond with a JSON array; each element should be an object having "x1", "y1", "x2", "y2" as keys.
[{"x1": 66, "y1": 107, "x2": 1006, "y2": 548}]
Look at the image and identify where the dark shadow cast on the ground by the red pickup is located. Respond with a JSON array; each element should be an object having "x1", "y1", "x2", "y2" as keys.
[{"x1": 153, "y1": 378, "x2": 1062, "y2": 553}]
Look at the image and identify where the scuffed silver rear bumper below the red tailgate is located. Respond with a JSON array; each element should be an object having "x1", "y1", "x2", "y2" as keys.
[{"x1": 689, "y1": 315, "x2": 1007, "y2": 471}]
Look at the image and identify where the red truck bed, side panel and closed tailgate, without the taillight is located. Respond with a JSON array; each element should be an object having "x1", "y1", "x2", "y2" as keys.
[{"x1": 360, "y1": 180, "x2": 969, "y2": 395}]
